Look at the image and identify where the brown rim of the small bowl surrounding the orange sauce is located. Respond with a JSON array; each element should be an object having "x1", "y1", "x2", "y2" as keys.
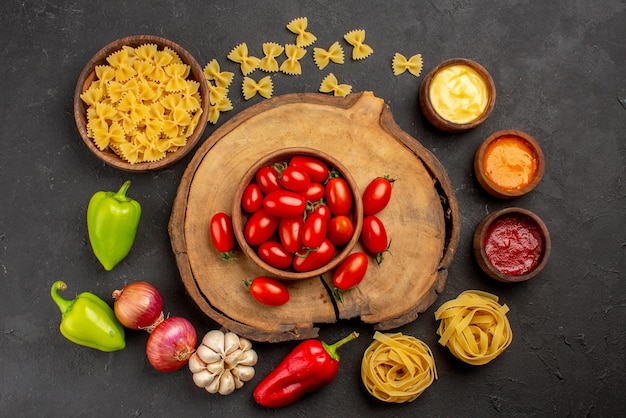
[{"x1": 474, "y1": 129, "x2": 546, "y2": 199}]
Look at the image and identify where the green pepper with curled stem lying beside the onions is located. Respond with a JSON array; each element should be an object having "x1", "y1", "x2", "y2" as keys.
[{"x1": 50, "y1": 280, "x2": 126, "y2": 352}]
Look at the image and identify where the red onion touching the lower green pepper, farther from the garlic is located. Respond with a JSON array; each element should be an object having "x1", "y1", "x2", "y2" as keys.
[{"x1": 113, "y1": 282, "x2": 163, "y2": 332}]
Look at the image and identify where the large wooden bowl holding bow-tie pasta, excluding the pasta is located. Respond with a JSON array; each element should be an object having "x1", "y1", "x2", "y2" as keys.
[{"x1": 74, "y1": 35, "x2": 209, "y2": 172}]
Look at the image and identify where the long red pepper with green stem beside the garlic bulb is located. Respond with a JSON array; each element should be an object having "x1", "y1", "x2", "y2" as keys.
[{"x1": 253, "y1": 332, "x2": 359, "y2": 408}]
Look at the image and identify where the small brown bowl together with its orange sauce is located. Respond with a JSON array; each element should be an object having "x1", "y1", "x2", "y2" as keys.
[{"x1": 474, "y1": 130, "x2": 545, "y2": 199}]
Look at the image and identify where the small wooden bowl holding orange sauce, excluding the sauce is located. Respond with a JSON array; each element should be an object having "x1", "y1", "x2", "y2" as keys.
[{"x1": 474, "y1": 129, "x2": 546, "y2": 199}]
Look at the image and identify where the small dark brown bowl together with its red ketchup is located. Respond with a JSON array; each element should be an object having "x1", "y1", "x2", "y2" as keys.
[{"x1": 473, "y1": 207, "x2": 552, "y2": 283}]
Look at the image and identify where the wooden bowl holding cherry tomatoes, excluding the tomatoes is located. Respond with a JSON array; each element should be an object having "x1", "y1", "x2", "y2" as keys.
[{"x1": 232, "y1": 147, "x2": 363, "y2": 280}]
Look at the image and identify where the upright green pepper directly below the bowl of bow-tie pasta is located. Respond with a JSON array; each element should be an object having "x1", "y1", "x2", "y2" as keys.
[{"x1": 87, "y1": 180, "x2": 141, "y2": 271}]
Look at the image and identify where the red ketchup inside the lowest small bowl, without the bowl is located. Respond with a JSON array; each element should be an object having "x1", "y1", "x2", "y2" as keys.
[{"x1": 485, "y1": 214, "x2": 544, "y2": 276}]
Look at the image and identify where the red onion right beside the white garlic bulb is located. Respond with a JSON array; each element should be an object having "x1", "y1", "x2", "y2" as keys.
[{"x1": 146, "y1": 316, "x2": 196, "y2": 372}]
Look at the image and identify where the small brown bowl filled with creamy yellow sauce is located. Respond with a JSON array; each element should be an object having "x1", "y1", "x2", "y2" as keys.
[{"x1": 419, "y1": 58, "x2": 496, "y2": 133}]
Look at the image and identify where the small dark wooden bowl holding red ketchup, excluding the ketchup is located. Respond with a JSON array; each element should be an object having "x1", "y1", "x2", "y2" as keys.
[{"x1": 473, "y1": 207, "x2": 552, "y2": 283}]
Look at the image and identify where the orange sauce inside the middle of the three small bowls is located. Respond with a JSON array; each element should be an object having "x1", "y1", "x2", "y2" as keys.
[{"x1": 483, "y1": 136, "x2": 538, "y2": 190}]
